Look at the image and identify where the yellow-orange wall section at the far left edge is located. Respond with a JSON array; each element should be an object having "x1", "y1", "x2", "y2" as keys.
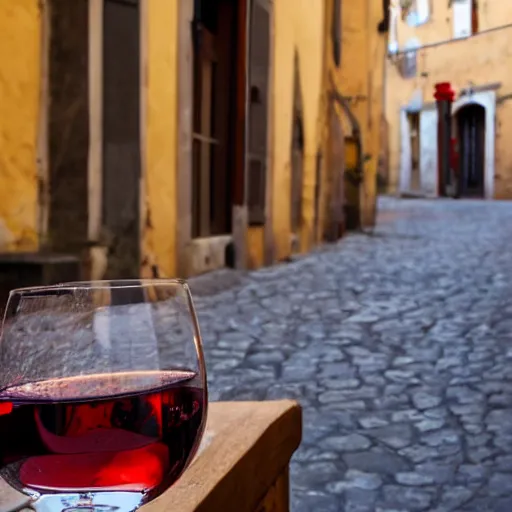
[{"x1": 0, "y1": 0, "x2": 41, "y2": 250}]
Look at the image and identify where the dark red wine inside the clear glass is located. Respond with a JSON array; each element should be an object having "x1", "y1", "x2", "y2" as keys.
[{"x1": 0, "y1": 371, "x2": 205, "y2": 493}]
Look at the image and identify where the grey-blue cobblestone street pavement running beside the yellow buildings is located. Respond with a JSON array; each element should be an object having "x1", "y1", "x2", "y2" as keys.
[{"x1": 193, "y1": 198, "x2": 512, "y2": 512}]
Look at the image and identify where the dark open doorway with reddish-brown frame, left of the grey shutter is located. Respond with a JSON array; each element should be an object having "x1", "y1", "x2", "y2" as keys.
[{"x1": 192, "y1": 0, "x2": 240, "y2": 238}]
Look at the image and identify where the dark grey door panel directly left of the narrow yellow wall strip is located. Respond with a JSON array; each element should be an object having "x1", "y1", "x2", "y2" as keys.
[{"x1": 103, "y1": 0, "x2": 141, "y2": 279}]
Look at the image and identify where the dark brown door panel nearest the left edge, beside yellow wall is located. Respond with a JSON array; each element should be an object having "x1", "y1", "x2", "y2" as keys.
[{"x1": 47, "y1": 0, "x2": 89, "y2": 254}]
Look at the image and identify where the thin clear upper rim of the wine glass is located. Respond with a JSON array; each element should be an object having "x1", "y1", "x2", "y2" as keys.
[{"x1": 9, "y1": 278, "x2": 189, "y2": 298}]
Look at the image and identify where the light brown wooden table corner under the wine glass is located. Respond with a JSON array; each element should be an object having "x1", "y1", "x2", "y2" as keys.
[{"x1": 0, "y1": 400, "x2": 302, "y2": 512}]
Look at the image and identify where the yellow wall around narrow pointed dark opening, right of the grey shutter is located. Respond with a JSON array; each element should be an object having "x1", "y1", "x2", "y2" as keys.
[{"x1": 271, "y1": 0, "x2": 324, "y2": 260}]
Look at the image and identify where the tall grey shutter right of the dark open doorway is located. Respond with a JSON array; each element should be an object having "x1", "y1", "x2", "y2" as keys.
[{"x1": 247, "y1": 0, "x2": 270, "y2": 225}]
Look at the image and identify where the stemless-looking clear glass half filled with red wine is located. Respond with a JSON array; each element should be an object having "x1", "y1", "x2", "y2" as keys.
[{"x1": 0, "y1": 279, "x2": 207, "y2": 512}]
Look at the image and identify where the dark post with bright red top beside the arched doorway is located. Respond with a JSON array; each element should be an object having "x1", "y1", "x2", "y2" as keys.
[{"x1": 434, "y1": 82, "x2": 455, "y2": 197}]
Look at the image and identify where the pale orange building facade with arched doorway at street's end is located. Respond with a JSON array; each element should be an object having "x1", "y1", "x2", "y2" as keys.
[{"x1": 385, "y1": 0, "x2": 512, "y2": 199}]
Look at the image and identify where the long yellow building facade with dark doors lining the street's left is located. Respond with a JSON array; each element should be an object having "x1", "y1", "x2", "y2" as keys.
[{"x1": 0, "y1": 0, "x2": 385, "y2": 279}]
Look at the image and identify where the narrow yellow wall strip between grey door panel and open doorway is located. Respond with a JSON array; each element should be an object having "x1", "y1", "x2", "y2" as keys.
[{"x1": 142, "y1": 0, "x2": 179, "y2": 277}]
